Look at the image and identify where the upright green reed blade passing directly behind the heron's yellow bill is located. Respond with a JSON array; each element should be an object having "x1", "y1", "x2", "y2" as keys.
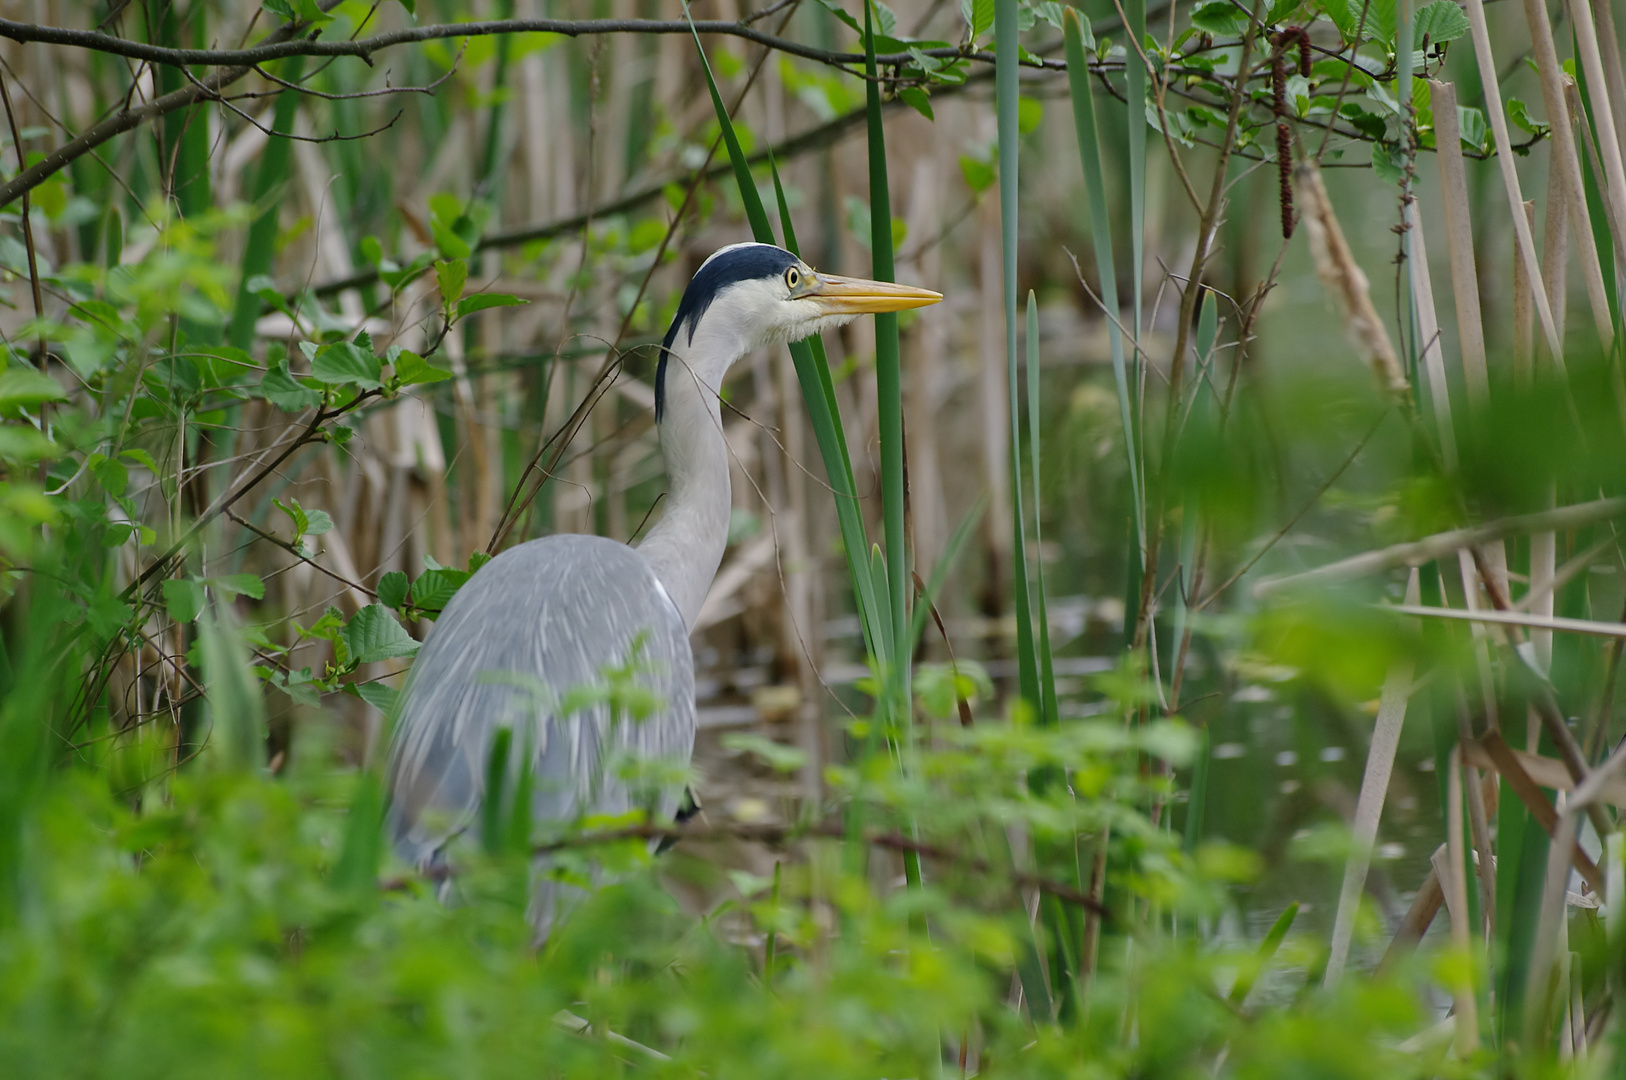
[{"x1": 863, "y1": 3, "x2": 911, "y2": 699}]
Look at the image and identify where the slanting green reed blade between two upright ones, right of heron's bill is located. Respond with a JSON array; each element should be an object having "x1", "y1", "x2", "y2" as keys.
[{"x1": 1062, "y1": 8, "x2": 1146, "y2": 566}]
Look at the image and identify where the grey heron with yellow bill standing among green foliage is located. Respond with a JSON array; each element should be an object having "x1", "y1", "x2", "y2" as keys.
[{"x1": 385, "y1": 242, "x2": 941, "y2": 935}]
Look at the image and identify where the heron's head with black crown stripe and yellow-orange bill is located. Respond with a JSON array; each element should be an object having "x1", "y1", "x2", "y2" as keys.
[{"x1": 655, "y1": 244, "x2": 943, "y2": 415}]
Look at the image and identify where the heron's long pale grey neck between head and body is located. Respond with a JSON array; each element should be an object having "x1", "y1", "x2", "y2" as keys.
[{"x1": 637, "y1": 335, "x2": 740, "y2": 629}]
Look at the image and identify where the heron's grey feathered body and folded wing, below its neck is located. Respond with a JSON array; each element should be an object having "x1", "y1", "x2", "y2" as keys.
[{"x1": 389, "y1": 535, "x2": 694, "y2": 865}]
